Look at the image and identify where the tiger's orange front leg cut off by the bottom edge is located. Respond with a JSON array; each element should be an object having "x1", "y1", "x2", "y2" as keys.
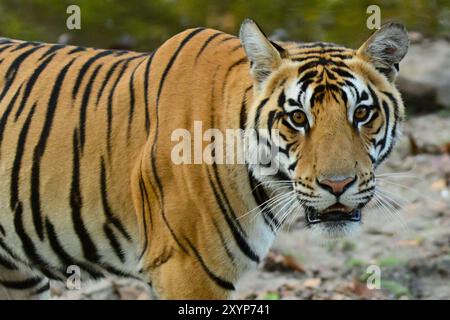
[{"x1": 151, "y1": 253, "x2": 234, "y2": 300}]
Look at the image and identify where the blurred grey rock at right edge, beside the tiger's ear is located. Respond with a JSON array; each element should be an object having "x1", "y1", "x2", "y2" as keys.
[{"x1": 397, "y1": 40, "x2": 450, "y2": 113}]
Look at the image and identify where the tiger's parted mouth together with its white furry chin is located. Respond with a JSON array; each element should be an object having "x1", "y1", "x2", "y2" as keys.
[{"x1": 305, "y1": 208, "x2": 362, "y2": 239}]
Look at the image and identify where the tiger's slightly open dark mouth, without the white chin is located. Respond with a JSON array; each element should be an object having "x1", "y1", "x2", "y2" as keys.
[{"x1": 305, "y1": 204, "x2": 361, "y2": 225}]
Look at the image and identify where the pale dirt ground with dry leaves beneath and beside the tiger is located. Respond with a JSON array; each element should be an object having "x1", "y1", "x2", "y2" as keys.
[{"x1": 52, "y1": 115, "x2": 450, "y2": 299}]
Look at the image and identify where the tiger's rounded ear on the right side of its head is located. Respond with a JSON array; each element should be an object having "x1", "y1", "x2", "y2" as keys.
[{"x1": 357, "y1": 22, "x2": 409, "y2": 81}]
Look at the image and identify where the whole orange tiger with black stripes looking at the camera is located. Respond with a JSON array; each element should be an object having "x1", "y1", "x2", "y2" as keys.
[{"x1": 0, "y1": 19, "x2": 409, "y2": 299}]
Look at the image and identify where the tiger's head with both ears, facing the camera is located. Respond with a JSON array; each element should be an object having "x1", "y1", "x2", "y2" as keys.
[{"x1": 240, "y1": 20, "x2": 409, "y2": 237}]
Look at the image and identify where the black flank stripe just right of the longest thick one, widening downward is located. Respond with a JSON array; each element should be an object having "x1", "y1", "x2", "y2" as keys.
[{"x1": 70, "y1": 129, "x2": 100, "y2": 262}]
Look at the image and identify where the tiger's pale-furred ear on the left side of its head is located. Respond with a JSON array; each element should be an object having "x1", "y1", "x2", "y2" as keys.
[{"x1": 239, "y1": 19, "x2": 287, "y2": 88}]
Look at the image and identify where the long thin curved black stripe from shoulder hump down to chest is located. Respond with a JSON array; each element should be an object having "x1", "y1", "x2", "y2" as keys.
[{"x1": 151, "y1": 28, "x2": 205, "y2": 253}]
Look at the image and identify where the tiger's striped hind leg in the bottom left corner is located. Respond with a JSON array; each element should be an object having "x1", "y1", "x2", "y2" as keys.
[{"x1": 0, "y1": 257, "x2": 50, "y2": 300}]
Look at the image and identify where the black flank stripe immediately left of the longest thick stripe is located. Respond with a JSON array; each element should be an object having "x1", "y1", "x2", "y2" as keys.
[{"x1": 10, "y1": 102, "x2": 36, "y2": 211}]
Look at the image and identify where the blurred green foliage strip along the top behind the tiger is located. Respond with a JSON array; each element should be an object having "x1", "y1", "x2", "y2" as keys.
[{"x1": 0, "y1": 0, "x2": 450, "y2": 51}]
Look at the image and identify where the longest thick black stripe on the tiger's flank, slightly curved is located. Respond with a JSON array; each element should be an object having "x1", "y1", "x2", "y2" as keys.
[{"x1": 30, "y1": 60, "x2": 74, "y2": 241}]
